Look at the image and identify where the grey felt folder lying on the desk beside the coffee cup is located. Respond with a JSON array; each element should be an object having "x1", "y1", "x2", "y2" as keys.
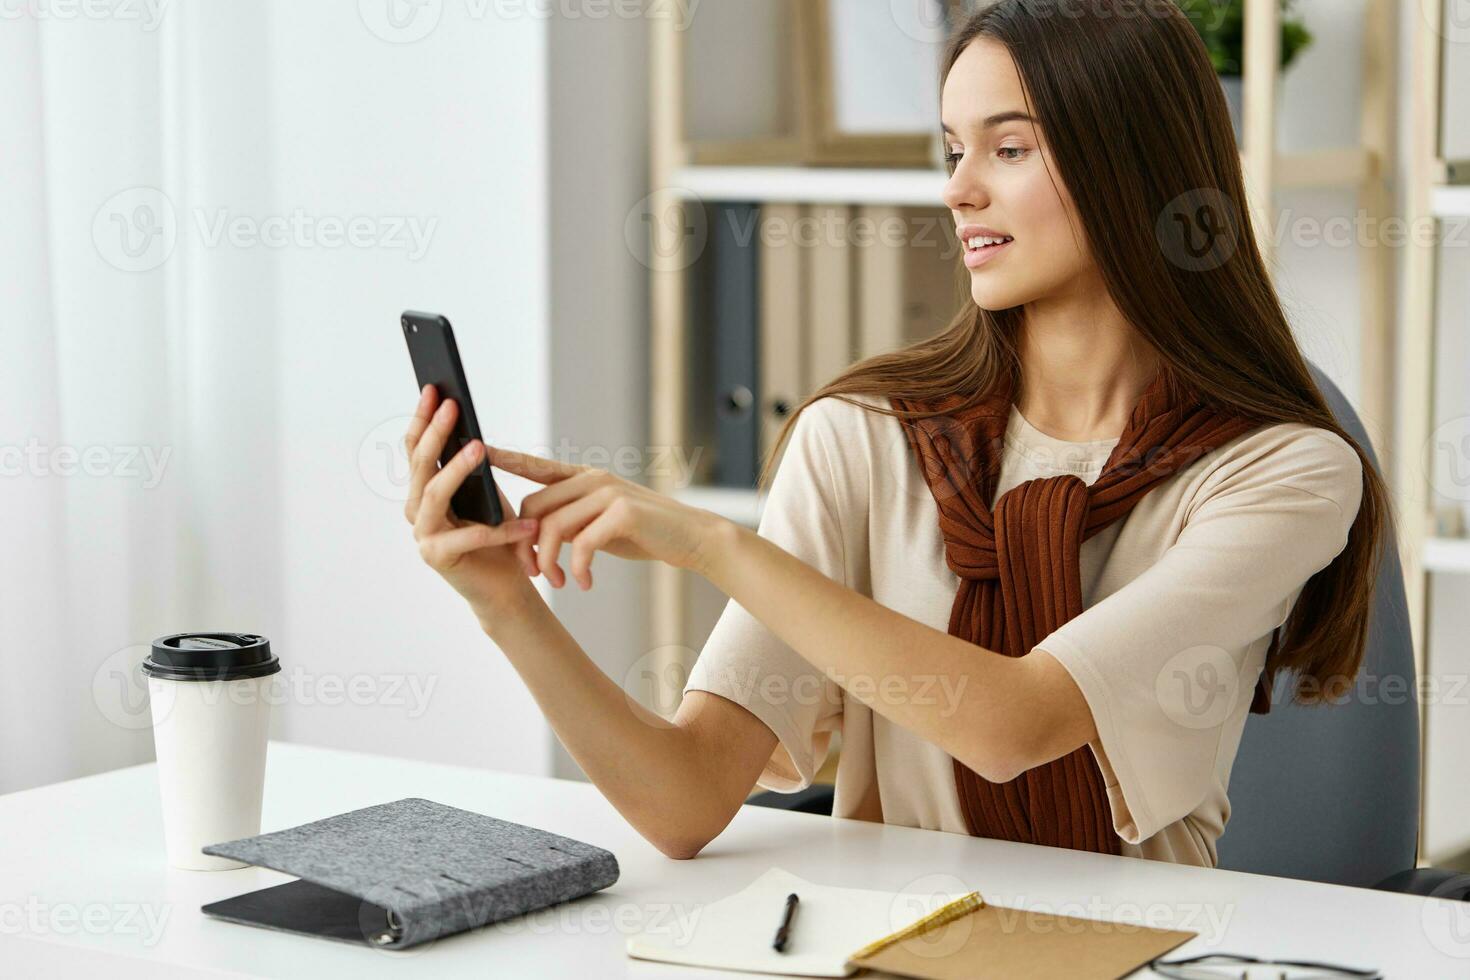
[{"x1": 200, "y1": 798, "x2": 617, "y2": 949}]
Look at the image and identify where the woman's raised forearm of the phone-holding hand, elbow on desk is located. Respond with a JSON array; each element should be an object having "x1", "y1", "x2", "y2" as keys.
[{"x1": 481, "y1": 579, "x2": 748, "y2": 857}]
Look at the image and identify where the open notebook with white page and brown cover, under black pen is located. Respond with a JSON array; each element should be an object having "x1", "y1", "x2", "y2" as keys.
[{"x1": 626, "y1": 868, "x2": 1195, "y2": 980}]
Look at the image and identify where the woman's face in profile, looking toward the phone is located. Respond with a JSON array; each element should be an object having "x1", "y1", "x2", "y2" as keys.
[{"x1": 941, "y1": 38, "x2": 1097, "y2": 310}]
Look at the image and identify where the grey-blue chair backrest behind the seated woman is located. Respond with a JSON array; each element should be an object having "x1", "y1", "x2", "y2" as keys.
[{"x1": 1217, "y1": 364, "x2": 1419, "y2": 886}]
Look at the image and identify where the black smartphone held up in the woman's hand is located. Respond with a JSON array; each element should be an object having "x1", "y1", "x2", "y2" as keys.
[{"x1": 400, "y1": 310, "x2": 506, "y2": 526}]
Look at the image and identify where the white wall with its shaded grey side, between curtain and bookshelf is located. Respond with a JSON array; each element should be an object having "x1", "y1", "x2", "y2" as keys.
[{"x1": 252, "y1": 3, "x2": 647, "y2": 774}]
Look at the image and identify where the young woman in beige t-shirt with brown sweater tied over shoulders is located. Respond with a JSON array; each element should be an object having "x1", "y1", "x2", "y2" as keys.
[{"x1": 406, "y1": 0, "x2": 1389, "y2": 865}]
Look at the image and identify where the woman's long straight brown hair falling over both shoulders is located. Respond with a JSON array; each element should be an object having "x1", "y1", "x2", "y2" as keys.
[{"x1": 759, "y1": 0, "x2": 1392, "y2": 704}]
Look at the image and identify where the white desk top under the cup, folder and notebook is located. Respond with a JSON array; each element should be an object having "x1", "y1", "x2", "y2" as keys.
[{"x1": 0, "y1": 742, "x2": 1470, "y2": 980}]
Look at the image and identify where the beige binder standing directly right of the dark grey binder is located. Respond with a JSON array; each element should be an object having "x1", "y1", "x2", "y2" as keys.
[{"x1": 757, "y1": 204, "x2": 807, "y2": 470}]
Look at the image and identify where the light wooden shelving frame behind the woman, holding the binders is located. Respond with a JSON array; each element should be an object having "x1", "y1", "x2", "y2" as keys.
[{"x1": 648, "y1": 0, "x2": 1399, "y2": 781}]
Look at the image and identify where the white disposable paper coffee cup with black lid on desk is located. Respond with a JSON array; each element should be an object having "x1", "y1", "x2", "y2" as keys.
[{"x1": 141, "y1": 633, "x2": 281, "y2": 871}]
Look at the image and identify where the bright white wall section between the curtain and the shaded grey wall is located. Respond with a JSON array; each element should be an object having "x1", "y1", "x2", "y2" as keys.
[{"x1": 257, "y1": 3, "x2": 553, "y2": 773}]
